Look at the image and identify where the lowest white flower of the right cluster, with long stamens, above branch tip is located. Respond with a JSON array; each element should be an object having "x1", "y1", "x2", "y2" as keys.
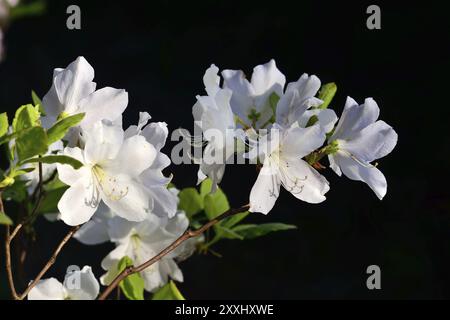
[{"x1": 250, "y1": 124, "x2": 329, "y2": 214}]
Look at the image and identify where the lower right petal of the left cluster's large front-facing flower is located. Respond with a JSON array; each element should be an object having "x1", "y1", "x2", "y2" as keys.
[{"x1": 101, "y1": 175, "x2": 153, "y2": 221}]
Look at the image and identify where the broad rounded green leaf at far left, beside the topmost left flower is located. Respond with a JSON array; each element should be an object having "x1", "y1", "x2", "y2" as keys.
[{"x1": 16, "y1": 127, "x2": 48, "y2": 161}]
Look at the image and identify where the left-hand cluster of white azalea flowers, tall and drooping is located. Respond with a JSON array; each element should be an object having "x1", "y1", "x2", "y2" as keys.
[{"x1": 32, "y1": 57, "x2": 194, "y2": 292}]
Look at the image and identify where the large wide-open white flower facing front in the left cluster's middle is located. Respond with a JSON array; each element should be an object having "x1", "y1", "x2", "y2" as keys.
[{"x1": 57, "y1": 121, "x2": 156, "y2": 225}]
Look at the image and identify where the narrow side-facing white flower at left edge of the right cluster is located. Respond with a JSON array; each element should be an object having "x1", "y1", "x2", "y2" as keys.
[{"x1": 192, "y1": 65, "x2": 242, "y2": 192}]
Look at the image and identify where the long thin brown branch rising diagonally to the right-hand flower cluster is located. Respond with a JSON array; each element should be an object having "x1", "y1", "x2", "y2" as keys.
[{"x1": 98, "y1": 204, "x2": 250, "y2": 300}]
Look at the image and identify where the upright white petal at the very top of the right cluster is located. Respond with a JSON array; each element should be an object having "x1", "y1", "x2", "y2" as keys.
[{"x1": 251, "y1": 59, "x2": 286, "y2": 96}]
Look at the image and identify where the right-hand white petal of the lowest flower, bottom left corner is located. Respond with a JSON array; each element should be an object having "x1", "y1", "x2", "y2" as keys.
[{"x1": 64, "y1": 266, "x2": 100, "y2": 300}]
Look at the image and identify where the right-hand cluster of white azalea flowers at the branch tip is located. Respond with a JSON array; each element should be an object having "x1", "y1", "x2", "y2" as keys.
[{"x1": 193, "y1": 60, "x2": 397, "y2": 214}]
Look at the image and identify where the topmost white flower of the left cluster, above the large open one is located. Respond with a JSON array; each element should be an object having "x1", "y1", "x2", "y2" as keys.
[{"x1": 42, "y1": 57, "x2": 128, "y2": 141}]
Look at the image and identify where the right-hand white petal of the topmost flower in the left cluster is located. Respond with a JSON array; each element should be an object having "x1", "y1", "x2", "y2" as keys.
[{"x1": 80, "y1": 87, "x2": 128, "y2": 126}]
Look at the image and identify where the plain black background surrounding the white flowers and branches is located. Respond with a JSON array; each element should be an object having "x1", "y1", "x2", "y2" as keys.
[{"x1": 0, "y1": 0, "x2": 450, "y2": 299}]
